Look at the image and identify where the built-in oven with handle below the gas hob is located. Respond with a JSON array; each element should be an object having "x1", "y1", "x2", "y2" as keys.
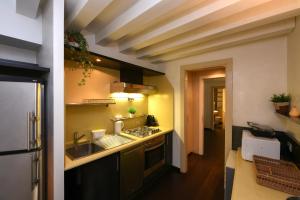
[{"x1": 144, "y1": 135, "x2": 165, "y2": 177}]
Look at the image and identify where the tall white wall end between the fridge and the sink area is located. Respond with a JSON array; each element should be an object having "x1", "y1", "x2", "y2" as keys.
[{"x1": 37, "y1": 0, "x2": 64, "y2": 200}]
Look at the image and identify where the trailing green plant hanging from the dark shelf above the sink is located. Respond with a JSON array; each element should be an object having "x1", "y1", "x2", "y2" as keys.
[{"x1": 64, "y1": 31, "x2": 94, "y2": 86}]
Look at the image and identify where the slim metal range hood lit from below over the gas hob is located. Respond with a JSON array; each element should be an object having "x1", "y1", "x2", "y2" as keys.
[{"x1": 110, "y1": 82, "x2": 157, "y2": 94}]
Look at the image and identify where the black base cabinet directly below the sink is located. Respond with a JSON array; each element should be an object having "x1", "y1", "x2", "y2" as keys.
[{"x1": 65, "y1": 153, "x2": 120, "y2": 200}]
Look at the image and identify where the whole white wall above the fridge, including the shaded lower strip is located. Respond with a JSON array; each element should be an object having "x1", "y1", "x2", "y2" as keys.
[{"x1": 0, "y1": 0, "x2": 43, "y2": 63}]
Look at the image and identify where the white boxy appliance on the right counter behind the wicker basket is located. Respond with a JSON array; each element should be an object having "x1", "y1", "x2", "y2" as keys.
[{"x1": 242, "y1": 130, "x2": 280, "y2": 161}]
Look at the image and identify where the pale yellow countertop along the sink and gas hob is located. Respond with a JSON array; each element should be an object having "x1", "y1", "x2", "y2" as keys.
[{"x1": 65, "y1": 127, "x2": 173, "y2": 171}]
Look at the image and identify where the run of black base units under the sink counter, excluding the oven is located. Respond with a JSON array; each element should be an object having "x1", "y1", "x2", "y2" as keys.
[{"x1": 65, "y1": 132, "x2": 173, "y2": 200}]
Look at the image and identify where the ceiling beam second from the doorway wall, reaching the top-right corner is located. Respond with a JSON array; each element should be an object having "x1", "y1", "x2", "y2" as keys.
[{"x1": 136, "y1": 1, "x2": 300, "y2": 58}]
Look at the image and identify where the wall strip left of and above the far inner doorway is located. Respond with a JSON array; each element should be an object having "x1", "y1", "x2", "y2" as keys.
[{"x1": 204, "y1": 78, "x2": 225, "y2": 129}]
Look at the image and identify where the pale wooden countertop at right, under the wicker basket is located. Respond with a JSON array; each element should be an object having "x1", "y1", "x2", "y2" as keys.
[{"x1": 231, "y1": 149, "x2": 293, "y2": 200}]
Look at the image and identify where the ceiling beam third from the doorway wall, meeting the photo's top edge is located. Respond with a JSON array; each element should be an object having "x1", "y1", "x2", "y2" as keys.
[{"x1": 120, "y1": 0, "x2": 270, "y2": 52}]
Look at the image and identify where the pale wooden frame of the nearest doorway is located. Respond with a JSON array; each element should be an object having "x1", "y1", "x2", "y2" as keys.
[{"x1": 180, "y1": 58, "x2": 233, "y2": 173}]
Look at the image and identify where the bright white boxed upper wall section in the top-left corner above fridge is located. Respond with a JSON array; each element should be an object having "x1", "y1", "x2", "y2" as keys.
[{"x1": 0, "y1": 0, "x2": 43, "y2": 45}]
